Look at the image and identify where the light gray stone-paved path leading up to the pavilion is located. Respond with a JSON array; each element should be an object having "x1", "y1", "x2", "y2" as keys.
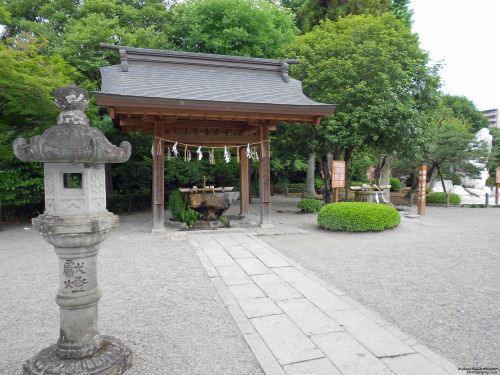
[{"x1": 189, "y1": 230, "x2": 458, "y2": 375}]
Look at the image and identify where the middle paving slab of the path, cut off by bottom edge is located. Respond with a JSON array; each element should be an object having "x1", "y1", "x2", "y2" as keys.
[{"x1": 312, "y1": 332, "x2": 394, "y2": 375}]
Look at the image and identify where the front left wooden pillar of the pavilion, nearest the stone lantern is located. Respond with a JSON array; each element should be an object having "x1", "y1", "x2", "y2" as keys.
[{"x1": 152, "y1": 120, "x2": 165, "y2": 232}]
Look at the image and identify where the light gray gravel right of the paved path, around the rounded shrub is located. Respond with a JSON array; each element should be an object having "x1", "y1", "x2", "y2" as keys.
[{"x1": 252, "y1": 197, "x2": 500, "y2": 367}]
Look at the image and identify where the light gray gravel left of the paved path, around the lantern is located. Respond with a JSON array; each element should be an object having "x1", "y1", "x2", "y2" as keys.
[{"x1": 0, "y1": 214, "x2": 263, "y2": 375}]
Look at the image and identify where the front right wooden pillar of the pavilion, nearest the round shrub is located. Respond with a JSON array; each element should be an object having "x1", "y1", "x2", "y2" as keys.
[{"x1": 259, "y1": 125, "x2": 272, "y2": 227}]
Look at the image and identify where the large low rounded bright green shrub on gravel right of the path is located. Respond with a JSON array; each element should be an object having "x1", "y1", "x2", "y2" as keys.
[{"x1": 318, "y1": 202, "x2": 401, "y2": 232}]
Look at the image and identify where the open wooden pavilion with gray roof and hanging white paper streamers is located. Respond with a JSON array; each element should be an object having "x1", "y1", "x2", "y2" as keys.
[{"x1": 93, "y1": 43, "x2": 335, "y2": 231}]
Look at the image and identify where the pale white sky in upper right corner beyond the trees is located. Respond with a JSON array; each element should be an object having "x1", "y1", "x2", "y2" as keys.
[{"x1": 409, "y1": 0, "x2": 500, "y2": 111}]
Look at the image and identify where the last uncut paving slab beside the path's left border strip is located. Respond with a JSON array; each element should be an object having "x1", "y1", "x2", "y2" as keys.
[{"x1": 251, "y1": 314, "x2": 324, "y2": 365}]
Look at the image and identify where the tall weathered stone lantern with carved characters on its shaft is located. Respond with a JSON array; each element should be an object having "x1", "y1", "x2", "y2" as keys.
[{"x1": 13, "y1": 84, "x2": 132, "y2": 374}]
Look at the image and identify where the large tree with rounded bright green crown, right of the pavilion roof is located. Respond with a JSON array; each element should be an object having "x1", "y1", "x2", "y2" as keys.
[{"x1": 285, "y1": 13, "x2": 439, "y2": 203}]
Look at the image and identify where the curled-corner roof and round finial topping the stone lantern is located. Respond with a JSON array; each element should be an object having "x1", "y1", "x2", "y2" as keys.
[{"x1": 13, "y1": 83, "x2": 132, "y2": 163}]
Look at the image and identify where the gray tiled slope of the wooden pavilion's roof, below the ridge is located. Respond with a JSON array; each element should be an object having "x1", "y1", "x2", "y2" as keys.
[{"x1": 101, "y1": 64, "x2": 331, "y2": 106}]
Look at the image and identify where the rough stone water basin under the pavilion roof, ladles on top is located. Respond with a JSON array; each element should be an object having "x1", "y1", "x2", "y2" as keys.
[{"x1": 179, "y1": 186, "x2": 240, "y2": 221}]
